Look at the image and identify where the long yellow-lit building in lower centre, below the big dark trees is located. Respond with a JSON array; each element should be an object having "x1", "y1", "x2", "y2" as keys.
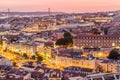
[{"x1": 55, "y1": 56, "x2": 96, "y2": 69}]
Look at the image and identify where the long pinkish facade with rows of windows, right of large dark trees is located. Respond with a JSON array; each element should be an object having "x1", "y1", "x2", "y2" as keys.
[{"x1": 73, "y1": 35, "x2": 120, "y2": 48}]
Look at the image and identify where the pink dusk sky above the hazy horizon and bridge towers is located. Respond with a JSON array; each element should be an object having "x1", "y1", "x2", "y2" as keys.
[{"x1": 0, "y1": 0, "x2": 120, "y2": 12}]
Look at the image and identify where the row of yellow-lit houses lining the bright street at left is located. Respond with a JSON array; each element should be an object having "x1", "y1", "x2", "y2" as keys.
[{"x1": 2, "y1": 41, "x2": 53, "y2": 56}]
